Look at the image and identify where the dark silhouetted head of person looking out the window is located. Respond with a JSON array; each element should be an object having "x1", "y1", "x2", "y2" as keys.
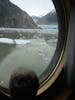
[{"x1": 9, "y1": 68, "x2": 39, "y2": 100}]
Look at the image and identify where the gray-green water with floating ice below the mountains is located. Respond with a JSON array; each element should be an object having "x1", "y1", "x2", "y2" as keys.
[{"x1": 0, "y1": 25, "x2": 58, "y2": 87}]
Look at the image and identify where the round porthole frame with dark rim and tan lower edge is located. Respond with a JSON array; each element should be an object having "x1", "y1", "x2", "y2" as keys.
[{"x1": 0, "y1": 0, "x2": 68, "y2": 96}]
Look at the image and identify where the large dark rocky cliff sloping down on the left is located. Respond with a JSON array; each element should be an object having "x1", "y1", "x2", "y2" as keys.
[{"x1": 0, "y1": 0, "x2": 37, "y2": 28}]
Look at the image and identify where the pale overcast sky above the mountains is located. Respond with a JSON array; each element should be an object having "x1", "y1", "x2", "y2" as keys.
[{"x1": 10, "y1": 0, "x2": 54, "y2": 16}]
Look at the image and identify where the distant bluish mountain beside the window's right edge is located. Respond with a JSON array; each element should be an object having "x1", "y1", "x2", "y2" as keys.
[{"x1": 37, "y1": 10, "x2": 57, "y2": 25}]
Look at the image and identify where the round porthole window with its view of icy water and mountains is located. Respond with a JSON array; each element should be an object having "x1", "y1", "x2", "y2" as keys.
[{"x1": 0, "y1": 0, "x2": 66, "y2": 94}]
